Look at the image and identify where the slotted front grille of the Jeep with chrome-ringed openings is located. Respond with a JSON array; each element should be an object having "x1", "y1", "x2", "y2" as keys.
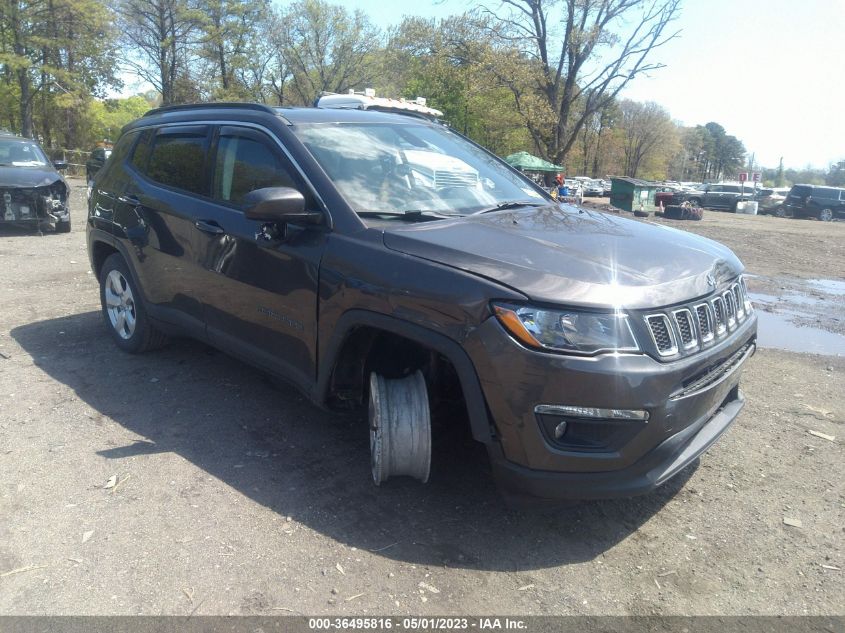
[{"x1": 645, "y1": 280, "x2": 752, "y2": 356}]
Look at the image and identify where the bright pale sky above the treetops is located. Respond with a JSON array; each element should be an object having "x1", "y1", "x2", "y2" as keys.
[{"x1": 120, "y1": 0, "x2": 845, "y2": 168}]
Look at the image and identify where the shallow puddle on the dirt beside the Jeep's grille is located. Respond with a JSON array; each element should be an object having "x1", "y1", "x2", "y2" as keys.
[{"x1": 748, "y1": 292, "x2": 845, "y2": 356}]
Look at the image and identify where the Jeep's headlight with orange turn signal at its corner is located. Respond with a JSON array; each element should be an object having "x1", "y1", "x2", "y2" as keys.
[{"x1": 493, "y1": 303, "x2": 640, "y2": 354}]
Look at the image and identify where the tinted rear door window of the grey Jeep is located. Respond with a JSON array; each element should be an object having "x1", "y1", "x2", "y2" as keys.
[{"x1": 145, "y1": 132, "x2": 207, "y2": 194}]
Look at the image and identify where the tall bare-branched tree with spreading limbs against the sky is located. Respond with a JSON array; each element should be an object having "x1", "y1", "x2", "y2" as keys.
[{"x1": 477, "y1": 0, "x2": 680, "y2": 163}]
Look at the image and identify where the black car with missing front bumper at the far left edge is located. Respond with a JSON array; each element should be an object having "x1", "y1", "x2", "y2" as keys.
[{"x1": 0, "y1": 134, "x2": 70, "y2": 233}]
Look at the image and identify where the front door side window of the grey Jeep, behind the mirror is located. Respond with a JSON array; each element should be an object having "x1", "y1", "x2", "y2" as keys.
[{"x1": 214, "y1": 132, "x2": 298, "y2": 205}]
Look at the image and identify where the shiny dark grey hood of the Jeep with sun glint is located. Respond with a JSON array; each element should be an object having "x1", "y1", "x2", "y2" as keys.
[{"x1": 384, "y1": 205, "x2": 743, "y2": 309}]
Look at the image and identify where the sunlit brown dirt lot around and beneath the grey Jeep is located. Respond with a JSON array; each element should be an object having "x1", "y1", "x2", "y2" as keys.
[{"x1": 0, "y1": 181, "x2": 845, "y2": 615}]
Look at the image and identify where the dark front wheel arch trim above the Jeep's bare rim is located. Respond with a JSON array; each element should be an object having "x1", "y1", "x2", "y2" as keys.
[{"x1": 315, "y1": 310, "x2": 494, "y2": 444}]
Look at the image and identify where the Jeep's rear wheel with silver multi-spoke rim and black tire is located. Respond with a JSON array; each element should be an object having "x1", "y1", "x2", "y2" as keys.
[{"x1": 100, "y1": 253, "x2": 167, "y2": 354}]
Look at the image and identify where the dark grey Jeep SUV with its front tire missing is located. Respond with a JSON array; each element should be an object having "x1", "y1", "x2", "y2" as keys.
[{"x1": 87, "y1": 104, "x2": 757, "y2": 498}]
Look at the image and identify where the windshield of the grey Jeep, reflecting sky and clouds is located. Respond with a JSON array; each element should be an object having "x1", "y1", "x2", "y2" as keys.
[{"x1": 293, "y1": 123, "x2": 548, "y2": 215}]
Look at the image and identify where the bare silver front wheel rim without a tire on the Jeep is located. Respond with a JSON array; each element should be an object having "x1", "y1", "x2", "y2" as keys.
[{"x1": 369, "y1": 371, "x2": 431, "y2": 486}]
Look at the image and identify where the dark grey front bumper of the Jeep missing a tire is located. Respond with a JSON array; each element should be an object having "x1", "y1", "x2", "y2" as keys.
[{"x1": 473, "y1": 316, "x2": 756, "y2": 499}]
